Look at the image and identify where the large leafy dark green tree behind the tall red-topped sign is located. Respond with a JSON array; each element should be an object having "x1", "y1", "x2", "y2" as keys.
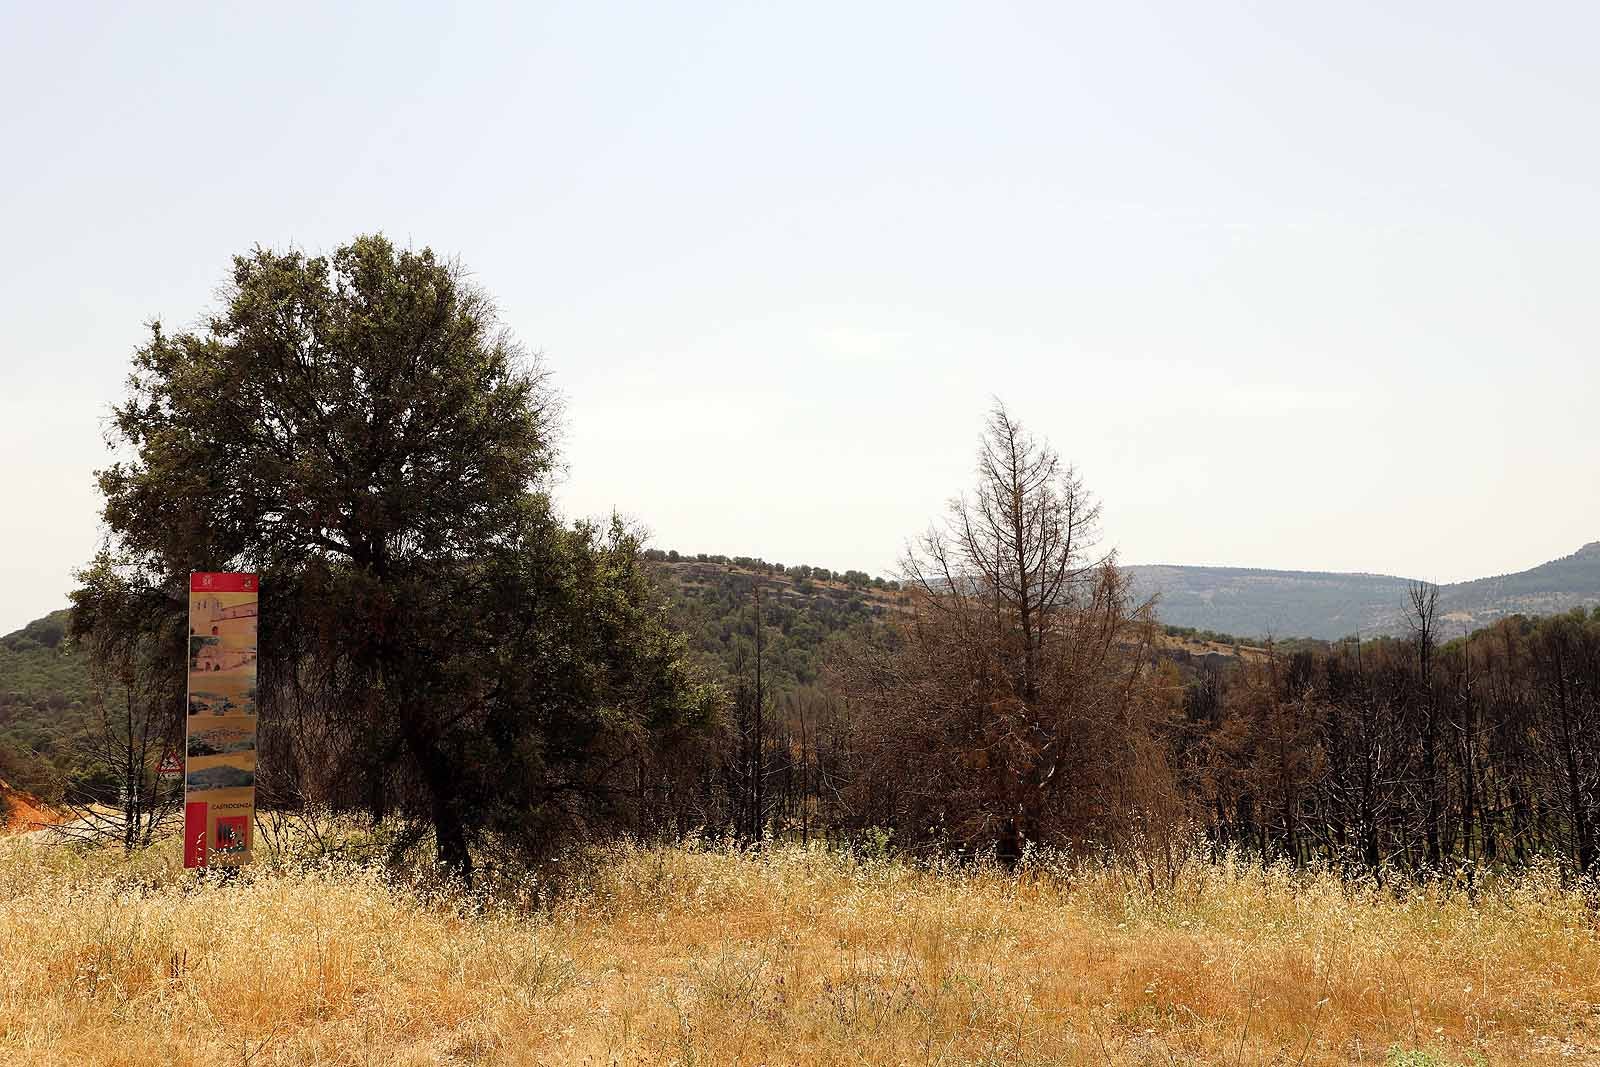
[{"x1": 86, "y1": 237, "x2": 715, "y2": 872}]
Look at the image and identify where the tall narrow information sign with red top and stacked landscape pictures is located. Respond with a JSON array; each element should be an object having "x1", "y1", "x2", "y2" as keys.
[{"x1": 184, "y1": 573, "x2": 261, "y2": 867}]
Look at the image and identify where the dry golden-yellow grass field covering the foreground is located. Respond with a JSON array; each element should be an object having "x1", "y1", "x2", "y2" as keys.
[{"x1": 0, "y1": 841, "x2": 1600, "y2": 1067}]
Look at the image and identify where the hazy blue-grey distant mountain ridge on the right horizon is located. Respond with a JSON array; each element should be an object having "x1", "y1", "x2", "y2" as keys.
[{"x1": 1125, "y1": 541, "x2": 1600, "y2": 640}]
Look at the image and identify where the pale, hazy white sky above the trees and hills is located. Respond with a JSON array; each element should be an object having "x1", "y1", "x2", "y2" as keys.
[{"x1": 0, "y1": 0, "x2": 1600, "y2": 632}]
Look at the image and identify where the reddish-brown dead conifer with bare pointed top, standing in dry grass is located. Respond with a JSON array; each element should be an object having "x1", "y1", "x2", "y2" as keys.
[{"x1": 840, "y1": 405, "x2": 1165, "y2": 857}]
